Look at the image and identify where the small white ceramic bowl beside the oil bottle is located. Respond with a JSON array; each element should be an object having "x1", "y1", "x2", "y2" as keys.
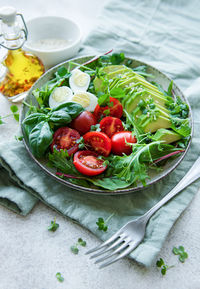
[{"x1": 24, "y1": 16, "x2": 81, "y2": 69}]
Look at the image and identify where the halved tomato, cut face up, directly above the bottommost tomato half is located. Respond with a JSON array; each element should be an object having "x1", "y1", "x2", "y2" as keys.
[{"x1": 83, "y1": 131, "x2": 111, "y2": 157}]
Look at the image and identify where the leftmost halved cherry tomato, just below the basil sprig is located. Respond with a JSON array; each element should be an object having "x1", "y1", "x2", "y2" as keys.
[{"x1": 51, "y1": 126, "x2": 80, "y2": 155}]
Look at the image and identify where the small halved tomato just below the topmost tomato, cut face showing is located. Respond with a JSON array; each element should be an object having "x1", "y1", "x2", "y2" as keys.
[{"x1": 100, "y1": 116, "x2": 124, "y2": 137}]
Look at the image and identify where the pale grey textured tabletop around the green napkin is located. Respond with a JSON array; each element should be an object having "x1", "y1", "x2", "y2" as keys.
[{"x1": 0, "y1": 0, "x2": 200, "y2": 289}]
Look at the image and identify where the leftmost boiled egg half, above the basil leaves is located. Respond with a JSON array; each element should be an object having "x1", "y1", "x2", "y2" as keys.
[{"x1": 49, "y1": 86, "x2": 73, "y2": 108}]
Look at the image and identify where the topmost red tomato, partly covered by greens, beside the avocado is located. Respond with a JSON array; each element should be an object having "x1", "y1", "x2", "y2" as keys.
[{"x1": 94, "y1": 97, "x2": 123, "y2": 120}]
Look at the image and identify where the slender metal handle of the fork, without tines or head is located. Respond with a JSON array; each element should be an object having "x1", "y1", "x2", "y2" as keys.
[{"x1": 144, "y1": 157, "x2": 200, "y2": 221}]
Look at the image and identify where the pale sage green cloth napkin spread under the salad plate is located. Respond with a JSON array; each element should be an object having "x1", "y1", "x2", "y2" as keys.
[{"x1": 0, "y1": 0, "x2": 200, "y2": 266}]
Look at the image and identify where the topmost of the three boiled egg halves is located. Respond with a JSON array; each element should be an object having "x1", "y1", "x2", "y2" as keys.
[{"x1": 69, "y1": 68, "x2": 90, "y2": 93}]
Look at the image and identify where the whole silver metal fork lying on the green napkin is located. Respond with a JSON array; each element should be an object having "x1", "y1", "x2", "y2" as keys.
[{"x1": 86, "y1": 157, "x2": 200, "y2": 268}]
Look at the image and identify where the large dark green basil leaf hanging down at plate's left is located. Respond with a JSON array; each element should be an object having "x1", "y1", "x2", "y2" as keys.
[{"x1": 29, "y1": 121, "x2": 53, "y2": 158}]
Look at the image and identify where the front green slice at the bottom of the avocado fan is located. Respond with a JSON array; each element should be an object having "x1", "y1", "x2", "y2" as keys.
[{"x1": 140, "y1": 115, "x2": 171, "y2": 132}]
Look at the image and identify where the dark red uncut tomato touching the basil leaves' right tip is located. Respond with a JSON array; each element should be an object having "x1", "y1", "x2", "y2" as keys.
[{"x1": 71, "y1": 111, "x2": 97, "y2": 135}]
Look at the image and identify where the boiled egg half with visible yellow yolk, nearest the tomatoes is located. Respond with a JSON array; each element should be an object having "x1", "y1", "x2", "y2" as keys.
[{"x1": 71, "y1": 91, "x2": 98, "y2": 111}]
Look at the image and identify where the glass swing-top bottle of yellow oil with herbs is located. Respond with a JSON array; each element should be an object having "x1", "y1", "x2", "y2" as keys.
[{"x1": 0, "y1": 7, "x2": 44, "y2": 102}]
